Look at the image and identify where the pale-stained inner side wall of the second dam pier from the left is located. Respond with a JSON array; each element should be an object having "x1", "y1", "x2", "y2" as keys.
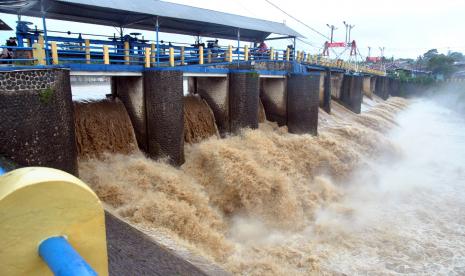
[{"x1": 112, "y1": 77, "x2": 147, "y2": 151}]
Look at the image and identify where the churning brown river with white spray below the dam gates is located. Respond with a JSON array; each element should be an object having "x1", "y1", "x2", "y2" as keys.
[{"x1": 77, "y1": 81, "x2": 465, "y2": 275}]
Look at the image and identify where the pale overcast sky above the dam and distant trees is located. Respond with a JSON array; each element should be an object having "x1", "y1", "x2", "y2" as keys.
[{"x1": 0, "y1": 0, "x2": 465, "y2": 58}]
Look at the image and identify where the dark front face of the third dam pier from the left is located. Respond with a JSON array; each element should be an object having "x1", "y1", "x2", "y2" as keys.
[{"x1": 229, "y1": 72, "x2": 260, "y2": 132}]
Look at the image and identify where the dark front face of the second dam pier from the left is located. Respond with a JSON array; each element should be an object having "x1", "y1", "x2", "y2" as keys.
[{"x1": 144, "y1": 70, "x2": 184, "y2": 165}]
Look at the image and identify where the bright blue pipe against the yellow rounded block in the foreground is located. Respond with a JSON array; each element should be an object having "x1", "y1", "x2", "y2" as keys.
[{"x1": 39, "y1": 237, "x2": 98, "y2": 276}]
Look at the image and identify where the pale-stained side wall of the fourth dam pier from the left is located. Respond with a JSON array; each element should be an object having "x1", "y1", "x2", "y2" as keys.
[{"x1": 260, "y1": 78, "x2": 287, "y2": 126}]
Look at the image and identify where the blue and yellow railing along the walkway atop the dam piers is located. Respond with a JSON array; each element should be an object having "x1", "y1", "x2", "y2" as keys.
[{"x1": 0, "y1": 36, "x2": 385, "y2": 75}]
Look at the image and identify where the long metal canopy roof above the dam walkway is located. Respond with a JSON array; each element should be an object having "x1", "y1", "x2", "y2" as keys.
[{"x1": 0, "y1": 0, "x2": 302, "y2": 42}]
